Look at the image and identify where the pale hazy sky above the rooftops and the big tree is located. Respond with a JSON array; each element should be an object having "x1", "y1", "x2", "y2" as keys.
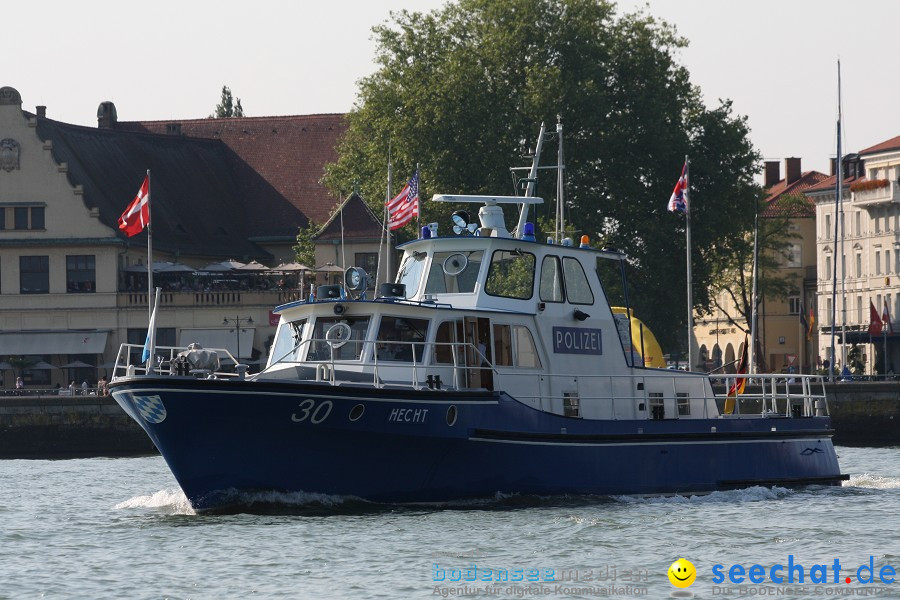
[{"x1": 7, "y1": 0, "x2": 900, "y2": 174}]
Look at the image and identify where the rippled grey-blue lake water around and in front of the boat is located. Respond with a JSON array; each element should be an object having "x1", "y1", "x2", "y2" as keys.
[{"x1": 0, "y1": 448, "x2": 900, "y2": 599}]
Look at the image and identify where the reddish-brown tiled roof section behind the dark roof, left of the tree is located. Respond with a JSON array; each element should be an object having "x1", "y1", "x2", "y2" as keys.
[{"x1": 115, "y1": 114, "x2": 347, "y2": 238}]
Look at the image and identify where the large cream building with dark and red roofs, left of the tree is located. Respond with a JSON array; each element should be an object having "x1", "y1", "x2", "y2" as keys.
[{"x1": 0, "y1": 87, "x2": 380, "y2": 389}]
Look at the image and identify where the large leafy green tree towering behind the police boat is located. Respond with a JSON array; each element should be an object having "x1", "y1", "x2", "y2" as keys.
[{"x1": 325, "y1": 0, "x2": 759, "y2": 351}]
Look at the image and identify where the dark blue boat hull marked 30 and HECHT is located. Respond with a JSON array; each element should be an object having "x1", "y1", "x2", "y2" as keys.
[{"x1": 111, "y1": 377, "x2": 843, "y2": 510}]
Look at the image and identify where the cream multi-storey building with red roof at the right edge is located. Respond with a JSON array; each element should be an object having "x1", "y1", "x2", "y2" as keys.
[{"x1": 808, "y1": 137, "x2": 900, "y2": 374}]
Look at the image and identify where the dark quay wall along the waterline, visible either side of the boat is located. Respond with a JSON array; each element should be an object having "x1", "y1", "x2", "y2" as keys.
[{"x1": 0, "y1": 381, "x2": 900, "y2": 458}]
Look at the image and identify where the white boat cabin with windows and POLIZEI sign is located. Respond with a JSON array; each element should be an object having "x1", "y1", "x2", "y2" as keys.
[{"x1": 254, "y1": 196, "x2": 718, "y2": 419}]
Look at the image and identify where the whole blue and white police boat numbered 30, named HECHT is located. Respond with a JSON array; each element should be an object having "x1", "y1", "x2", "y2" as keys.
[{"x1": 110, "y1": 130, "x2": 846, "y2": 511}]
